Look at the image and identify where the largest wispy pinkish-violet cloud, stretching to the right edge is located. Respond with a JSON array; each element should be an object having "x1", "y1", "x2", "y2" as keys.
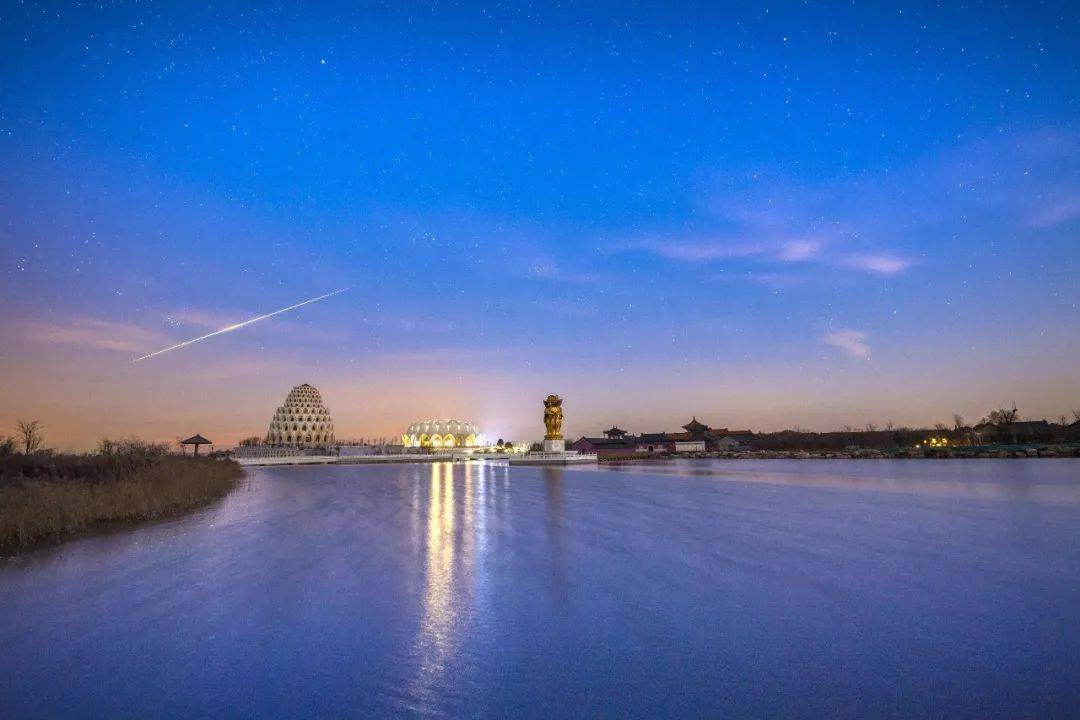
[{"x1": 612, "y1": 131, "x2": 1080, "y2": 277}]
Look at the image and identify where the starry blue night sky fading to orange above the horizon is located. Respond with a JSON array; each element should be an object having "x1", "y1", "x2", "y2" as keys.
[{"x1": 0, "y1": 1, "x2": 1080, "y2": 447}]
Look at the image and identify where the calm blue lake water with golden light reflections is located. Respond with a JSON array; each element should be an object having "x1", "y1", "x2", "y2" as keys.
[{"x1": 0, "y1": 460, "x2": 1080, "y2": 718}]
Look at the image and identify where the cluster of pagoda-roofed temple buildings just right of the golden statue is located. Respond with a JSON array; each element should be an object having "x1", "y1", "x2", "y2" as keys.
[{"x1": 570, "y1": 418, "x2": 753, "y2": 457}]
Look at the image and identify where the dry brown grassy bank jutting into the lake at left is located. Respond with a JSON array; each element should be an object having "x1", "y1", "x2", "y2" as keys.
[{"x1": 0, "y1": 453, "x2": 243, "y2": 551}]
